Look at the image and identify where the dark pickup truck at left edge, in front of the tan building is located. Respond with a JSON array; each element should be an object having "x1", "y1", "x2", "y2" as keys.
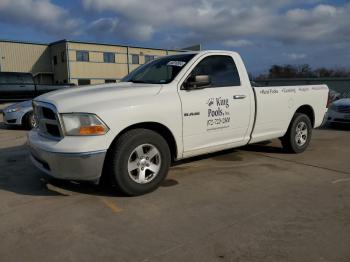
[{"x1": 0, "y1": 72, "x2": 72, "y2": 101}]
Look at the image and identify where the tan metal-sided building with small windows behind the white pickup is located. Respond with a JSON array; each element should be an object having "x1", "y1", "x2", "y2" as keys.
[{"x1": 0, "y1": 39, "x2": 185, "y2": 85}]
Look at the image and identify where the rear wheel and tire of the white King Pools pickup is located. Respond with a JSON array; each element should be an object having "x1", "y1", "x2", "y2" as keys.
[{"x1": 281, "y1": 113, "x2": 312, "y2": 154}]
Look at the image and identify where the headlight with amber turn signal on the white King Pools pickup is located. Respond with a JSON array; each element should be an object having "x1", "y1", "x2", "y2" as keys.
[{"x1": 61, "y1": 113, "x2": 109, "y2": 136}]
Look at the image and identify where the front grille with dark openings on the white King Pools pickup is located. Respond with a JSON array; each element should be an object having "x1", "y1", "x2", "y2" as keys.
[{"x1": 33, "y1": 101, "x2": 63, "y2": 140}]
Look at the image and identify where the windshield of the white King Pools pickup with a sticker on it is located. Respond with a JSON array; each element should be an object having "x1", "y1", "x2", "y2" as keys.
[{"x1": 121, "y1": 54, "x2": 196, "y2": 84}]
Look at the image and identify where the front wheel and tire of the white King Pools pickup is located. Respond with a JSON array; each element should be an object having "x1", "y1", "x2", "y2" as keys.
[{"x1": 106, "y1": 129, "x2": 171, "y2": 196}]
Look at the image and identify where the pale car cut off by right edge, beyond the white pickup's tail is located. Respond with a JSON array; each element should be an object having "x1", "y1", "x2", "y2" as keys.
[{"x1": 326, "y1": 98, "x2": 350, "y2": 123}]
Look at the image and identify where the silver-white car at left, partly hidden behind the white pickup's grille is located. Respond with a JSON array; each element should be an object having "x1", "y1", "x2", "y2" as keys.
[{"x1": 2, "y1": 100, "x2": 37, "y2": 129}]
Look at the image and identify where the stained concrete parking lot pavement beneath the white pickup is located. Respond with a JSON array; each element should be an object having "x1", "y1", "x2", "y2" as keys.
[{"x1": 0, "y1": 108, "x2": 350, "y2": 262}]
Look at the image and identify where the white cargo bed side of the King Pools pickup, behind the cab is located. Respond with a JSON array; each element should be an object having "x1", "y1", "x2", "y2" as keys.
[{"x1": 250, "y1": 85, "x2": 328, "y2": 143}]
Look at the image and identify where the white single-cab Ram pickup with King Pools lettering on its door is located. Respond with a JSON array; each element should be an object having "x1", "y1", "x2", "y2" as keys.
[{"x1": 28, "y1": 51, "x2": 328, "y2": 195}]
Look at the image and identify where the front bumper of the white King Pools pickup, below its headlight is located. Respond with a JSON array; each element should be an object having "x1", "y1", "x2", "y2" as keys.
[{"x1": 28, "y1": 130, "x2": 106, "y2": 181}]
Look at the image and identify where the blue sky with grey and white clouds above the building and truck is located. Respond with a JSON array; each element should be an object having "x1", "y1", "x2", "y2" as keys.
[{"x1": 0, "y1": 0, "x2": 350, "y2": 75}]
